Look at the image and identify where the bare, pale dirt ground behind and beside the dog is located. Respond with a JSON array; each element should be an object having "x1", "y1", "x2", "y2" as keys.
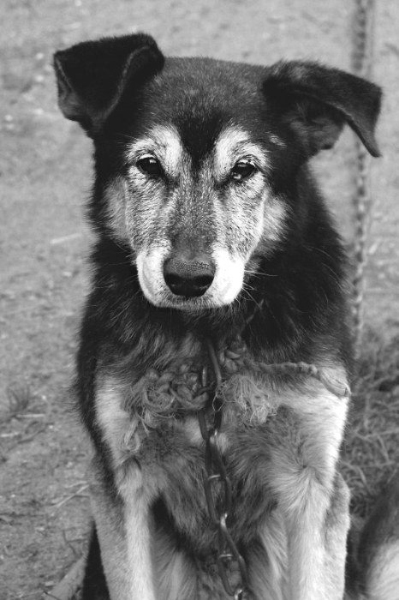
[{"x1": 0, "y1": 0, "x2": 399, "y2": 600}]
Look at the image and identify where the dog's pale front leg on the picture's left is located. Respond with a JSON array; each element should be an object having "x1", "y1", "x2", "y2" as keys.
[{"x1": 93, "y1": 377, "x2": 156, "y2": 600}]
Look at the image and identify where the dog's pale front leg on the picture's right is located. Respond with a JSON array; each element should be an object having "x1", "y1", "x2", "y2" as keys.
[{"x1": 275, "y1": 382, "x2": 349, "y2": 600}]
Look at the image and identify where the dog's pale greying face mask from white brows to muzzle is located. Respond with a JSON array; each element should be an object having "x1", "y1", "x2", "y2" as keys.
[{"x1": 126, "y1": 122, "x2": 278, "y2": 308}]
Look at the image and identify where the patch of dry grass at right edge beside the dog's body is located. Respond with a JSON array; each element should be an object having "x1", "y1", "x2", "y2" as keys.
[{"x1": 342, "y1": 330, "x2": 399, "y2": 517}]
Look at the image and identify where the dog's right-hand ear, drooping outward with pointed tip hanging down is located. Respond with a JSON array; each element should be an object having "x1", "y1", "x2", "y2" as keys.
[{"x1": 263, "y1": 61, "x2": 381, "y2": 156}]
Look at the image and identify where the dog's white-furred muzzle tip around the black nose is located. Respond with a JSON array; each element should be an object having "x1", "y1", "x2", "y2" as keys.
[{"x1": 136, "y1": 249, "x2": 245, "y2": 311}]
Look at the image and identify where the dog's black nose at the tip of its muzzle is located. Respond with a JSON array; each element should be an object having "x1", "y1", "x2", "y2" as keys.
[{"x1": 163, "y1": 254, "x2": 215, "y2": 298}]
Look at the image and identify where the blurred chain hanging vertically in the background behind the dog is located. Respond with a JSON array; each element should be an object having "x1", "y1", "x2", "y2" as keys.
[{"x1": 352, "y1": 0, "x2": 375, "y2": 351}]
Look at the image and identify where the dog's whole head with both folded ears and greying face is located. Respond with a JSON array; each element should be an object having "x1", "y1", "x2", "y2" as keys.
[{"x1": 55, "y1": 34, "x2": 381, "y2": 310}]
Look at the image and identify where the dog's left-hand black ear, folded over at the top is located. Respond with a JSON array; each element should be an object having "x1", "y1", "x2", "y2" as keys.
[{"x1": 54, "y1": 34, "x2": 164, "y2": 134}]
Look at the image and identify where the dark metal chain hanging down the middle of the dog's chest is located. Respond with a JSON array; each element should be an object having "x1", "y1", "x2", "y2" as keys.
[{"x1": 198, "y1": 341, "x2": 250, "y2": 600}]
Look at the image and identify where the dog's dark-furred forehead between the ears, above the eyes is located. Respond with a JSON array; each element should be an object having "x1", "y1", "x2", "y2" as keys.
[{"x1": 135, "y1": 59, "x2": 272, "y2": 162}]
